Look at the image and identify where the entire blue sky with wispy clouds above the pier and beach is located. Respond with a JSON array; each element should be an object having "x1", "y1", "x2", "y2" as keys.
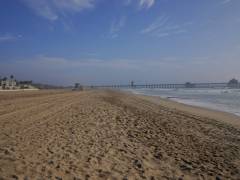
[{"x1": 0, "y1": 0, "x2": 240, "y2": 85}]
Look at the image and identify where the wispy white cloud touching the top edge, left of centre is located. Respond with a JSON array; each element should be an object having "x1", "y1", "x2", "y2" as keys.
[{"x1": 22, "y1": 0, "x2": 95, "y2": 21}]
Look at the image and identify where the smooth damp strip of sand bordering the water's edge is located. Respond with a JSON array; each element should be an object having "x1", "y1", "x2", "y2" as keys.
[{"x1": 124, "y1": 91, "x2": 240, "y2": 127}]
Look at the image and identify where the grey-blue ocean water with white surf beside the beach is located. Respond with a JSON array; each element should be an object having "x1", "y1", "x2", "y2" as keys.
[{"x1": 129, "y1": 88, "x2": 240, "y2": 116}]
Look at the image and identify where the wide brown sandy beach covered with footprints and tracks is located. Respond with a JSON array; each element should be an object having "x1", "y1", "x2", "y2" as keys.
[{"x1": 0, "y1": 91, "x2": 240, "y2": 180}]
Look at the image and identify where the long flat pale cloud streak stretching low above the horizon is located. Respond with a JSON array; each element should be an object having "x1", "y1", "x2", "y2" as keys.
[{"x1": 18, "y1": 55, "x2": 213, "y2": 70}]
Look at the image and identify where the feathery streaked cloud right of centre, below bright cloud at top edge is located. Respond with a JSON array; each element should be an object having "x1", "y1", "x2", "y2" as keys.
[{"x1": 140, "y1": 15, "x2": 191, "y2": 38}]
